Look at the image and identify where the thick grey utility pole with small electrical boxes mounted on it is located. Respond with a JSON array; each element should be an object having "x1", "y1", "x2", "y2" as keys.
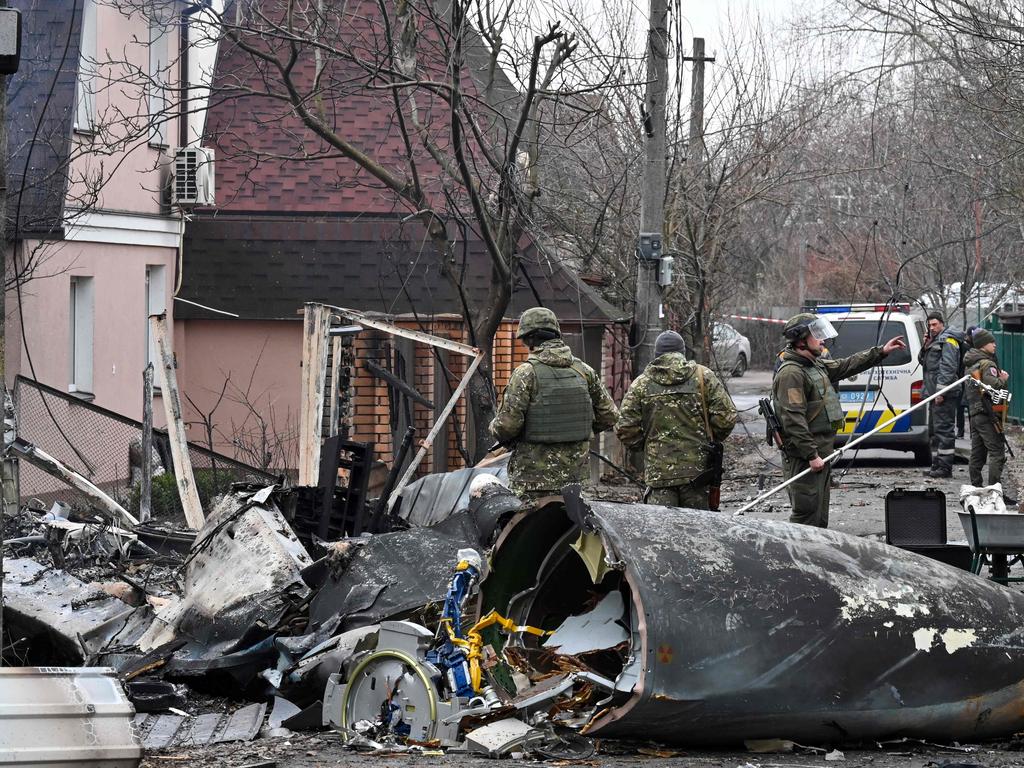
[{"x1": 633, "y1": 0, "x2": 669, "y2": 376}]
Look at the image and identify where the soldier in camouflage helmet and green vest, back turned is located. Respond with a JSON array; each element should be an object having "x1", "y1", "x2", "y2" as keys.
[{"x1": 490, "y1": 307, "x2": 618, "y2": 502}]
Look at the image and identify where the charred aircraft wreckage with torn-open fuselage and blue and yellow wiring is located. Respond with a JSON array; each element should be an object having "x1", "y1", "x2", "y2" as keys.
[{"x1": 6, "y1": 477, "x2": 1024, "y2": 745}]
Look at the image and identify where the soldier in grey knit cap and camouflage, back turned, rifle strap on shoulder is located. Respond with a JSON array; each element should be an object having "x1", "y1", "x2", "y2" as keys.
[{"x1": 615, "y1": 331, "x2": 736, "y2": 509}]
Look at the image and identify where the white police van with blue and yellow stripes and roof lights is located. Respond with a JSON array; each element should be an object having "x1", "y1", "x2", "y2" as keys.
[{"x1": 808, "y1": 304, "x2": 932, "y2": 466}]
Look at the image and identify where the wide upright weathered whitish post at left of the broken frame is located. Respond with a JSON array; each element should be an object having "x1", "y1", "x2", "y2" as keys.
[{"x1": 299, "y1": 302, "x2": 331, "y2": 485}]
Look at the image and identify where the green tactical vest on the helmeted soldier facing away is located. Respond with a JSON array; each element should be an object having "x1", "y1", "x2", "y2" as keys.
[{"x1": 522, "y1": 360, "x2": 594, "y2": 442}]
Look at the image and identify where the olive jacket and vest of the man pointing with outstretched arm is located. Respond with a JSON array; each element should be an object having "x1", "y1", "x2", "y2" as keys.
[{"x1": 772, "y1": 347, "x2": 886, "y2": 461}]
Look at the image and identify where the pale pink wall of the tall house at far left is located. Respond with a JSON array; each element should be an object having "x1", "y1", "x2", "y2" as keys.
[{"x1": 6, "y1": 3, "x2": 179, "y2": 426}]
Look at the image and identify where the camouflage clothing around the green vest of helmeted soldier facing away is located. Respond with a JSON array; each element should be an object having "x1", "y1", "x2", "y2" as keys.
[{"x1": 489, "y1": 339, "x2": 618, "y2": 493}]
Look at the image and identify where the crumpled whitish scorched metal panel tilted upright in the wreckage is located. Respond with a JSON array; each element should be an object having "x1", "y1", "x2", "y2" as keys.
[{"x1": 139, "y1": 489, "x2": 312, "y2": 657}]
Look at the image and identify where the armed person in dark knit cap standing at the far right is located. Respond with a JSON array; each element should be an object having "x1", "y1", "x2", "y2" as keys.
[{"x1": 964, "y1": 329, "x2": 1016, "y2": 504}]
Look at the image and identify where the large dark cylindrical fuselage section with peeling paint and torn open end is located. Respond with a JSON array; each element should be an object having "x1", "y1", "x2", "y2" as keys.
[{"x1": 481, "y1": 503, "x2": 1024, "y2": 744}]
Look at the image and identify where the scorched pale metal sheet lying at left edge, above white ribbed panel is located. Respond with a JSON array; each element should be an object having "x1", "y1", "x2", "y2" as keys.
[{"x1": 3, "y1": 558, "x2": 153, "y2": 664}]
